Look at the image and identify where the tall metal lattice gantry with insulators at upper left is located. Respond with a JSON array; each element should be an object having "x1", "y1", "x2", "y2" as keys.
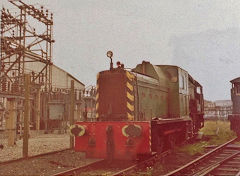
[{"x1": 0, "y1": 0, "x2": 54, "y2": 95}]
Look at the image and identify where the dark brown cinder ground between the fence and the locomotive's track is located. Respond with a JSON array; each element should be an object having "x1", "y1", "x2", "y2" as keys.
[{"x1": 0, "y1": 149, "x2": 101, "y2": 176}]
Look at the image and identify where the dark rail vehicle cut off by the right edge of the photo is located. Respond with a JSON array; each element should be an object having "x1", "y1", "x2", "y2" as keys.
[{"x1": 228, "y1": 77, "x2": 240, "y2": 138}]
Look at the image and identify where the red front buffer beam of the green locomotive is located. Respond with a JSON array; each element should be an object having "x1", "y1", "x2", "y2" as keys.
[{"x1": 75, "y1": 121, "x2": 151, "y2": 159}]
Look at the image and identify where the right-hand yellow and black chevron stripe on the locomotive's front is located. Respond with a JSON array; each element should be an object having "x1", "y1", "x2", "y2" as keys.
[{"x1": 126, "y1": 71, "x2": 135, "y2": 120}]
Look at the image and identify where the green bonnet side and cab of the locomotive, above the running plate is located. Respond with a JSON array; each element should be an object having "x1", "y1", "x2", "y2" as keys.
[{"x1": 132, "y1": 61, "x2": 203, "y2": 126}]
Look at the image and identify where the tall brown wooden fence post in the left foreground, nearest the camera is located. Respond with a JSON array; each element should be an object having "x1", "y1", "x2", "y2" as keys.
[{"x1": 23, "y1": 74, "x2": 30, "y2": 158}]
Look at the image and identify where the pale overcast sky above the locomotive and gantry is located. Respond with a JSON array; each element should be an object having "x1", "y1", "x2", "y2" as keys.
[{"x1": 0, "y1": 0, "x2": 240, "y2": 100}]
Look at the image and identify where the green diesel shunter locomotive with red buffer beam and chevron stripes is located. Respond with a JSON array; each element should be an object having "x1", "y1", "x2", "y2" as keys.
[{"x1": 71, "y1": 52, "x2": 204, "y2": 159}]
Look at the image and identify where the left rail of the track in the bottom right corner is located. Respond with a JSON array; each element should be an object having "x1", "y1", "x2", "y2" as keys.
[{"x1": 164, "y1": 138, "x2": 237, "y2": 176}]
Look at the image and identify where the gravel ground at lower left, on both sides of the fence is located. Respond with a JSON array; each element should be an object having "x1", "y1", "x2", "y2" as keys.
[{"x1": 0, "y1": 134, "x2": 101, "y2": 175}]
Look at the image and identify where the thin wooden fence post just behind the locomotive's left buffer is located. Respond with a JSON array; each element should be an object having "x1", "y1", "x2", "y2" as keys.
[{"x1": 69, "y1": 80, "x2": 75, "y2": 148}]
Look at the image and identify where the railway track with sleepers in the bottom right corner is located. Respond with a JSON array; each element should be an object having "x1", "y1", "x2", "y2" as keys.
[{"x1": 165, "y1": 138, "x2": 240, "y2": 176}]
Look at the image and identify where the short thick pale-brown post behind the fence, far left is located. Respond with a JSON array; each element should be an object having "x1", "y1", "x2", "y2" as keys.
[{"x1": 6, "y1": 98, "x2": 17, "y2": 146}]
